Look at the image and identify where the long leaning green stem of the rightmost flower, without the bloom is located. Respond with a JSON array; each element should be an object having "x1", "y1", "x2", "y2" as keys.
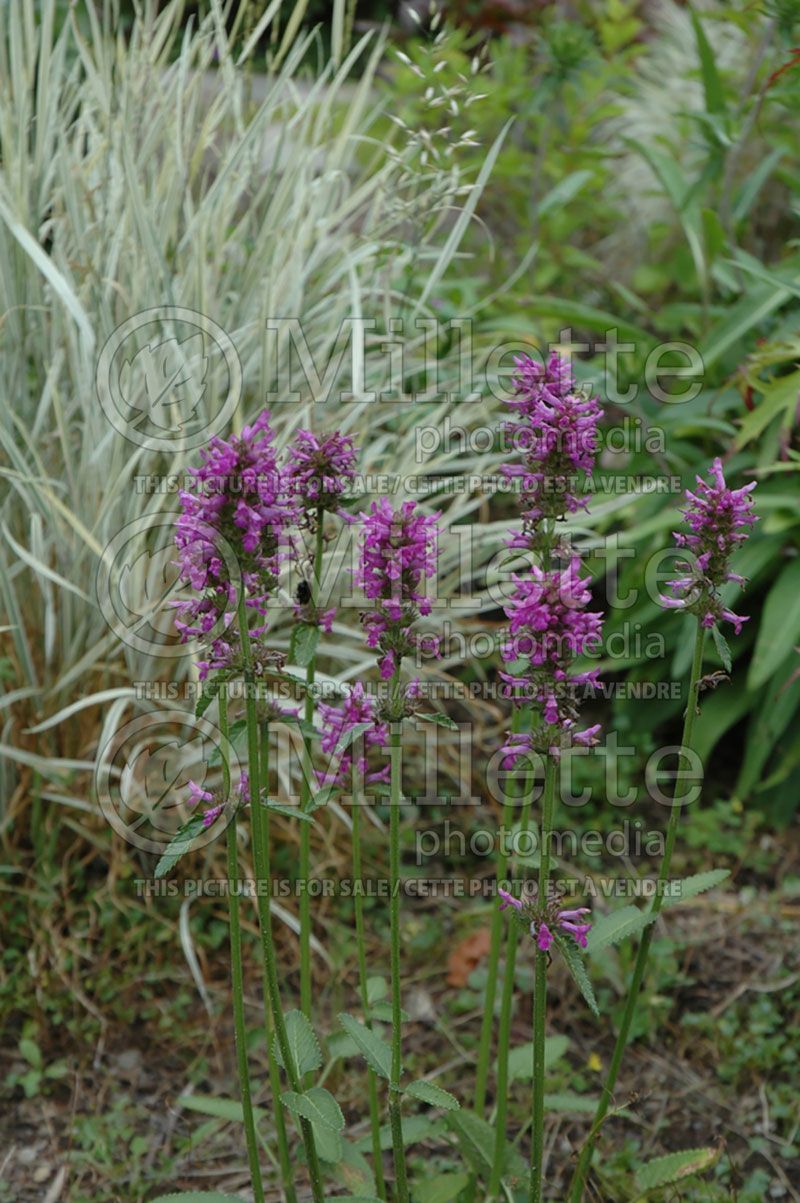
[{"x1": 569, "y1": 620, "x2": 705, "y2": 1203}]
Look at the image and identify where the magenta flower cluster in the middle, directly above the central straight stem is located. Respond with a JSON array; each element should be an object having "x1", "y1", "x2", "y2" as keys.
[{"x1": 355, "y1": 497, "x2": 439, "y2": 681}]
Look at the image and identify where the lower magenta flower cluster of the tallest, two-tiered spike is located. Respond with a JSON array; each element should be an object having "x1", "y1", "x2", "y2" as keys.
[{"x1": 499, "y1": 556, "x2": 603, "y2": 764}]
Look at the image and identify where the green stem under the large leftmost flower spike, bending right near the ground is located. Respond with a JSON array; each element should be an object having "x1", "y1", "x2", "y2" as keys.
[{"x1": 238, "y1": 589, "x2": 325, "y2": 1203}]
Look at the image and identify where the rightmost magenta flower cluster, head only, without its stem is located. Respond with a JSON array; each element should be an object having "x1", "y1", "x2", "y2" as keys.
[{"x1": 662, "y1": 458, "x2": 757, "y2": 634}]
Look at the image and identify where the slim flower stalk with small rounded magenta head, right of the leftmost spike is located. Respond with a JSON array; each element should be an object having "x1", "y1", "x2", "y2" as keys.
[{"x1": 283, "y1": 431, "x2": 356, "y2": 1018}]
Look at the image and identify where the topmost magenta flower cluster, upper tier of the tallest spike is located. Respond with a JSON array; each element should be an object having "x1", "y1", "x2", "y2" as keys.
[{"x1": 500, "y1": 351, "x2": 600, "y2": 536}]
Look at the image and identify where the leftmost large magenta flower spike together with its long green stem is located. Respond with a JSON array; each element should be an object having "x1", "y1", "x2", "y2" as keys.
[{"x1": 176, "y1": 411, "x2": 325, "y2": 1203}]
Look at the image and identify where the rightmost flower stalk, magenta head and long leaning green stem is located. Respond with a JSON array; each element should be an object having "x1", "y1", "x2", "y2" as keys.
[{"x1": 569, "y1": 458, "x2": 755, "y2": 1203}]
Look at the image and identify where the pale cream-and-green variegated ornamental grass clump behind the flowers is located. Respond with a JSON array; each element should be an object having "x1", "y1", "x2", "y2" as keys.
[{"x1": 0, "y1": 0, "x2": 512, "y2": 822}]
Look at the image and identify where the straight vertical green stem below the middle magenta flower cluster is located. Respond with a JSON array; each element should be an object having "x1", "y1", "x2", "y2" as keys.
[{"x1": 389, "y1": 721, "x2": 408, "y2": 1203}]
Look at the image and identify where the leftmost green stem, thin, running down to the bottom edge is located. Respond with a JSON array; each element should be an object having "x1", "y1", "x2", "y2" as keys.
[{"x1": 219, "y1": 688, "x2": 263, "y2": 1203}]
